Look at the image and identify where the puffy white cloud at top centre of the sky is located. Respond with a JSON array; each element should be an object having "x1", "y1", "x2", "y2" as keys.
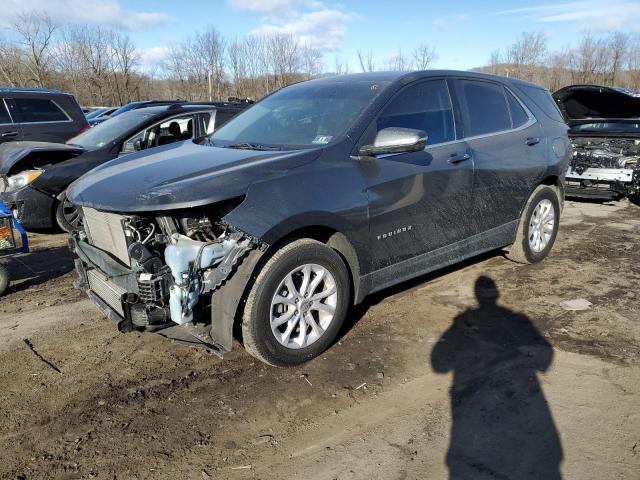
[{"x1": 227, "y1": 0, "x2": 353, "y2": 50}]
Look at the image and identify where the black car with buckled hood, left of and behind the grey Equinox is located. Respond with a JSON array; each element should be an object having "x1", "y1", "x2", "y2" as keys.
[{"x1": 0, "y1": 102, "x2": 246, "y2": 232}]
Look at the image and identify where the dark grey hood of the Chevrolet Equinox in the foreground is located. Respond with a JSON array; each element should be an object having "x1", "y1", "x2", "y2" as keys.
[{"x1": 67, "y1": 141, "x2": 319, "y2": 213}]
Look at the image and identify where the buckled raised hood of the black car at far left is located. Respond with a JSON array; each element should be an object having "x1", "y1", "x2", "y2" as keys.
[{"x1": 0, "y1": 142, "x2": 84, "y2": 175}]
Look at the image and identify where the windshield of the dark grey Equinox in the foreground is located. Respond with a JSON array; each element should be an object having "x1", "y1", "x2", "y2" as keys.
[{"x1": 210, "y1": 80, "x2": 389, "y2": 148}]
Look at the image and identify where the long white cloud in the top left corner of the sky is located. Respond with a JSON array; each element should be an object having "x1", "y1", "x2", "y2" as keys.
[{"x1": 0, "y1": 0, "x2": 171, "y2": 30}]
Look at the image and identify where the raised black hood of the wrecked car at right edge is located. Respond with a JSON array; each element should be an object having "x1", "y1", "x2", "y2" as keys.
[{"x1": 553, "y1": 85, "x2": 640, "y2": 125}]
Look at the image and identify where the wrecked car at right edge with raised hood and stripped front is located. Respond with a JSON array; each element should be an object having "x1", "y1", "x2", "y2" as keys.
[{"x1": 553, "y1": 85, "x2": 640, "y2": 199}]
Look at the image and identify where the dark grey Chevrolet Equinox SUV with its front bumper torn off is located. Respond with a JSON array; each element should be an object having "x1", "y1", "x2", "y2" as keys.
[{"x1": 69, "y1": 71, "x2": 570, "y2": 366}]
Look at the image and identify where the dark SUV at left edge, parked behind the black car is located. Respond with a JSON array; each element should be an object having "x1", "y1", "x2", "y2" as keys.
[{"x1": 0, "y1": 88, "x2": 89, "y2": 143}]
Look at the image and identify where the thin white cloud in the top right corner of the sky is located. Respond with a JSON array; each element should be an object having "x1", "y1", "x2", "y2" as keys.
[{"x1": 498, "y1": 0, "x2": 640, "y2": 31}]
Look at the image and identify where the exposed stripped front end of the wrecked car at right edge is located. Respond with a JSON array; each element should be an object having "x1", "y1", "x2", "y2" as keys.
[{"x1": 567, "y1": 136, "x2": 640, "y2": 198}]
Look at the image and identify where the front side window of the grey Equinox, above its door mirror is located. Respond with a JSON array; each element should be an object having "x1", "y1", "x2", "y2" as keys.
[{"x1": 376, "y1": 80, "x2": 455, "y2": 145}]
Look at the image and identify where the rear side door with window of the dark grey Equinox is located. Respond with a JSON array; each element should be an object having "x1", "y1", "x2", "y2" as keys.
[{"x1": 454, "y1": 79, "x2": 547, "y2": 233}]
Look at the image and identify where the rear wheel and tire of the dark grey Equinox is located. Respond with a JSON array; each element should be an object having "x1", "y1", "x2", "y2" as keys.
[{"x1": 506, "y1": 185, "x2": 560, "y2": 264}]
